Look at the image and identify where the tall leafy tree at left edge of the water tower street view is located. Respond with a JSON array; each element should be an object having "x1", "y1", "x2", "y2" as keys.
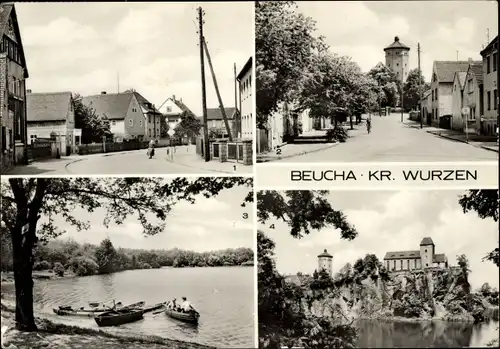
[{"x1": 255, "y1": 1, "x2": 325, "y2": 128}]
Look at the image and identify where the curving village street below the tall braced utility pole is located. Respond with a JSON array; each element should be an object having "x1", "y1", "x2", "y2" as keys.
[{"x1": 9, "y1": 146, "x2": 252, "y2": 175}]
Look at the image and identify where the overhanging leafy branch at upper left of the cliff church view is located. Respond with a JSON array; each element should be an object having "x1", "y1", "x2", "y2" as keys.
[{"x1": 257, "y1": 190, "x2": 358, "y2": 240}]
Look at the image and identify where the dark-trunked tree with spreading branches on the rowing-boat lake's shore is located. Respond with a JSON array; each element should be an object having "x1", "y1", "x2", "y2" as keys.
[{"x1": 1, "y1": 177, "x2": 253, "y2": 331}]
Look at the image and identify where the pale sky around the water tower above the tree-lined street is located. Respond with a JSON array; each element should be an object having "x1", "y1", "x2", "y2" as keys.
[{"x1": 299, "y1": 0, "x2": 498, "y2": 81}]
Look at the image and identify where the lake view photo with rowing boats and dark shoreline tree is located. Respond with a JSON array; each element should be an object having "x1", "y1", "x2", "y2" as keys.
[{"x1": 1, "y1": 177, "x2": 256, "y2": 349}]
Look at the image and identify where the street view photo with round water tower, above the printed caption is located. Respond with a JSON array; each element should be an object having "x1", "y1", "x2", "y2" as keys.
[{"x1": 255, "y1": 1, "x2": 500, "y2": 163}]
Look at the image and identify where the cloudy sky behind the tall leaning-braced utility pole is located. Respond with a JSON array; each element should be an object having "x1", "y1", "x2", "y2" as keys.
[{"x1": 16, "y1": 2, "x2": 254, "y2": 115}]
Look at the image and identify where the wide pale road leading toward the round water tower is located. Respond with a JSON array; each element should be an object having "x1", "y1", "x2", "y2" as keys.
[{"x1": 279, "y1": 114, "x2": 498, "y2": 163}]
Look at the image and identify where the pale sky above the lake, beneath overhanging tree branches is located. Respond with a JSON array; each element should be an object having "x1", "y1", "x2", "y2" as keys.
[{"x1": 56, "y1": 182, "x2": 255, "y2": 252}]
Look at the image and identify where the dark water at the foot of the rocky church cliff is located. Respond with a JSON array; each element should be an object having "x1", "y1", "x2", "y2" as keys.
[{"x1": 357, "y1": 320, "x2": 498, "y2": 348}]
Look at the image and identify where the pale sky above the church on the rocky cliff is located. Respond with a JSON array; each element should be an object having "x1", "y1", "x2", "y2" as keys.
[{"x1": 259, "y1": 190, "x2": 499, "y2": 288}]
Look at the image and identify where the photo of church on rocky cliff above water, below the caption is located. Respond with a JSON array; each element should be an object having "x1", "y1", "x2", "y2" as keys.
[{"x1": 257, "y1": 189, "x2": 499, "y2": 348}]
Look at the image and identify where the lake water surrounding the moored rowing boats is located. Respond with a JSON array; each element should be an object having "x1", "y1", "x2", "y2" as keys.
[{"x1": 2, "y1": 267, "x2": 255, "y2": 348}]
